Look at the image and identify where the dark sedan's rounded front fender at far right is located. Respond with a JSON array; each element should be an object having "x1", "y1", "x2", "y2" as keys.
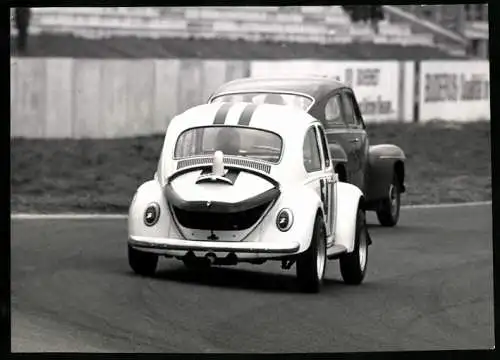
[{"x1": 366, "y1": 144, "x2": 406, "y2": 203}]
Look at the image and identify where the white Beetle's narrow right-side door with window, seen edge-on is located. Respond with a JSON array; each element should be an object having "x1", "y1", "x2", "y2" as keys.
[{"x1": 316, "y1": 126, "x2": 335, "y2": 245}]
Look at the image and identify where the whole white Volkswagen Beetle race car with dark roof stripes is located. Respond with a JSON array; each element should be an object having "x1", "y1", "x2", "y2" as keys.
[{"x1": 128, "y1": 102, "x2": 371, "y2": 292}]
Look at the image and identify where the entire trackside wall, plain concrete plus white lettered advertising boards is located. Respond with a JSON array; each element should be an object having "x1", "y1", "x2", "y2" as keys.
[{"x1": 10, "y1": 58, "x2": 490, "y2": 139}]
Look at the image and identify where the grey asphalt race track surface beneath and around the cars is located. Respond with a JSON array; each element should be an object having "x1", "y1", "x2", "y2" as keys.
[{"x1": 11, "y1": 205, "x2": 494, "y2": 352}]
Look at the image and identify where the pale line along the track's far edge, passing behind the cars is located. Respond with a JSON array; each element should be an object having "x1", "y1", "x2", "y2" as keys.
[{"x1": 10, "y1": 201, "x2": 492, "y2": 220}]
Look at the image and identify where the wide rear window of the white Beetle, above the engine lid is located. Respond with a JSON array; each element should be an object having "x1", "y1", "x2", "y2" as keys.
[{"x1": 174, "y1": 126, "x2": 282, "y2": 163}]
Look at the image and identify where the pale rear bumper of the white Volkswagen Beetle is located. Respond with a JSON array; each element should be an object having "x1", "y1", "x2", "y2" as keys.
[{"x1": 128, "y1": 236, "x2": 300, "y2": 255}]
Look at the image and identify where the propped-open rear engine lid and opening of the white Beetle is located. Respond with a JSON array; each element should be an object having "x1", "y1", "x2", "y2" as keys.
[{"x1": 164, "y1": 152, "x2": 281, "y2": 241}]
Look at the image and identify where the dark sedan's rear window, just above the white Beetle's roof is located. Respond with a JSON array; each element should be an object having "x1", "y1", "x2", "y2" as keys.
[{"x1": 211, "y1": 92, "x2": 312, "y2": 111}]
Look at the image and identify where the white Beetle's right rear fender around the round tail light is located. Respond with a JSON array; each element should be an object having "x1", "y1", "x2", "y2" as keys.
[{"x1": 260, "y1": 186, "x2": 322, "y2": 253}]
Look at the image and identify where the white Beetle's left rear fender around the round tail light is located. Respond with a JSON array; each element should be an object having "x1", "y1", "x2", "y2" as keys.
[{"x1": 128, "y1": 180, "x2": 182, "y2": 239}]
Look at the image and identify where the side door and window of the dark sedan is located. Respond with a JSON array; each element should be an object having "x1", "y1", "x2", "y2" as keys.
[{"x1": 341, "y1": 89, "x2": 368, "y2": 192}]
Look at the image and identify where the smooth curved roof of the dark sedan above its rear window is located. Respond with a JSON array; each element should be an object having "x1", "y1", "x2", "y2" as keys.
[{"x1": 212, "y1": 76, "x2": 346, "y2": 99}]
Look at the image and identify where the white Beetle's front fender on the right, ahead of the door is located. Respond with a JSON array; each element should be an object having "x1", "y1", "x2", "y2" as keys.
[{"x1": 335, "y1": 181, "x2": 363, "y2": 252}]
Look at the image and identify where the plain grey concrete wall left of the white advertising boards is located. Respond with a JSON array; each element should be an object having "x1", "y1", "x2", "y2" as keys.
[{"x1": 10, "y1": 58, "x2": 249, "y2": 139}]
